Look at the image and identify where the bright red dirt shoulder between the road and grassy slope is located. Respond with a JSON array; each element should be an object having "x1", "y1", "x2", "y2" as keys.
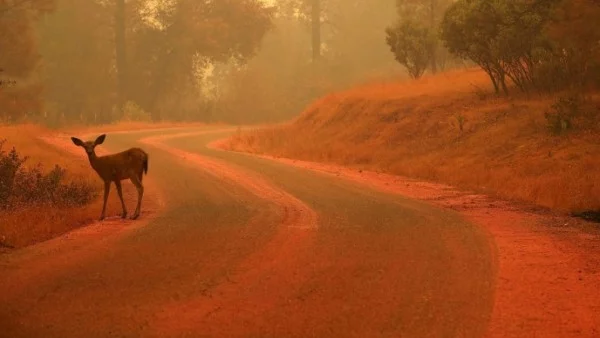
[{"x1": 211, "y1": 141, "x2": 600, "y2": 337}]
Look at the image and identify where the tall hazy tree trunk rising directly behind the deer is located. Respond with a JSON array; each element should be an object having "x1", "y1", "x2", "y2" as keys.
[{"x1": 115, "y1": 0, "x2": 127, "y2": 113}]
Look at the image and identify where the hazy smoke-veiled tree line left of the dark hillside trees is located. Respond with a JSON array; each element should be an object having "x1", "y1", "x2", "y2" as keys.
[{"x1": 0, "y1": 0, "x2": 400, "y2": 125}]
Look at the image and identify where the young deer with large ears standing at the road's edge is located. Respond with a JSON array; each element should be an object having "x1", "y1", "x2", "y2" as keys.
[{"x1": 71, "y1": 134, "x2": 148, "y2": 221}]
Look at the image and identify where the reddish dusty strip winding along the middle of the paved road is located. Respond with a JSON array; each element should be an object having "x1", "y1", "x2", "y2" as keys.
[{"x1": 140, "y1": 129, "x2": 318, "y2": 336}]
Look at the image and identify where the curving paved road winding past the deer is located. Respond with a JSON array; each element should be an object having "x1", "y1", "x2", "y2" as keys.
[{"x1": 0, "y1": 128, "x2": 497, "y2": 337}]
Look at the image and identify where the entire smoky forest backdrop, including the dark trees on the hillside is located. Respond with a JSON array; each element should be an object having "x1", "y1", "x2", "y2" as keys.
[{"x1": 0, "y1": 0, "x2": 600, "y2": 126}]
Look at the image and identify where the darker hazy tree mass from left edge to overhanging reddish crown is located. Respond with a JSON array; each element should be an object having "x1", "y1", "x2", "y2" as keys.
[{"x1": 0, "y1": 0, "x2": 272, "y2": 124}]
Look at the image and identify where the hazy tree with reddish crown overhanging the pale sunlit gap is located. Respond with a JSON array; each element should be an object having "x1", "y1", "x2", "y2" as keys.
[{"x1": 128, "y1": 0, "x2": 272, "y2": 119}]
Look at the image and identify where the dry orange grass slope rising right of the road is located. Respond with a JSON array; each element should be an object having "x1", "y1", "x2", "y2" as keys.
[{"x1": 228, "y1": 70, "x2": 600, "y2": 211}]
